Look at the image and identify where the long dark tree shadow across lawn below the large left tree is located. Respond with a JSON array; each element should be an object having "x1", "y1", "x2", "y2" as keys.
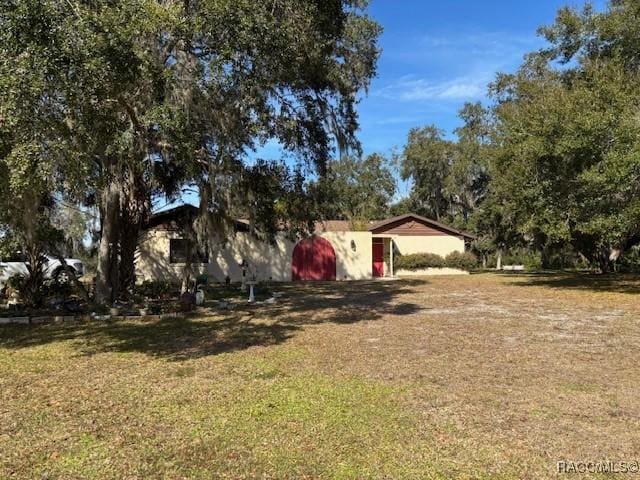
[{"x1": 0, "y1": 279, "x2": 426, "y2": 361}]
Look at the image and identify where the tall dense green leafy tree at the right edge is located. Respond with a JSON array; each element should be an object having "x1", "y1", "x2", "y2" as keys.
[{"x1": 492, "y1": 0, "x2": 640, "y2": 270}]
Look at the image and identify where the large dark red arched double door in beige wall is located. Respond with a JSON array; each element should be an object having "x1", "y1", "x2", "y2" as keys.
[{"x1": 291, "y1": 236, "x2": 336, "y2": 280}]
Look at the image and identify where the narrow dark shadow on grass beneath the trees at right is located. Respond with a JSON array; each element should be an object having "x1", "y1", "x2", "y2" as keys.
[{"x1": 497, "y1": 272, "x2": 640, "y2": 294}]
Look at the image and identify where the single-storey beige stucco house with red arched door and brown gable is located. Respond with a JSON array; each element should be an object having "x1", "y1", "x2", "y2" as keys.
[{"x1": 136, "y1": 205, "x2": 473, "y2": 281}]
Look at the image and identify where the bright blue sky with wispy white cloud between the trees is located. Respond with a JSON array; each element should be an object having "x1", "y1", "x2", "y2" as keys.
[{"x1": 169, "y1": 0, "x2": 605, "y2": 208}]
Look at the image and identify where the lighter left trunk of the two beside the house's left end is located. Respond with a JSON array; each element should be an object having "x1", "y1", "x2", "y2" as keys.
[{"x1": 95, "y1": 180, "x2": 120, "y2": 304}]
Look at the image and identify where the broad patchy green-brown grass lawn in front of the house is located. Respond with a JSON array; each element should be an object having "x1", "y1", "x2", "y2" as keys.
[{"x1": 0, "y1": 274, "x2": 640, "y2": 480}]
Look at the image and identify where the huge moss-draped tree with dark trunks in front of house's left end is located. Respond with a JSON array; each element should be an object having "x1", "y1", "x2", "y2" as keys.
[{"x1": 0, "y1": 0, "x2": 380, "y2": 300}]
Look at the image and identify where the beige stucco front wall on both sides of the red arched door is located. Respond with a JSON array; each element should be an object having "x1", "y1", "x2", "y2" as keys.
[{"x1": 136, "y1": 230, "x2": 371, "y2": 282}]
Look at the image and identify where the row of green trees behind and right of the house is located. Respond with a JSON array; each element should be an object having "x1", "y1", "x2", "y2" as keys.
[{"x1": 393, "y1": 0, "x2": 640, "y2": 272}]
